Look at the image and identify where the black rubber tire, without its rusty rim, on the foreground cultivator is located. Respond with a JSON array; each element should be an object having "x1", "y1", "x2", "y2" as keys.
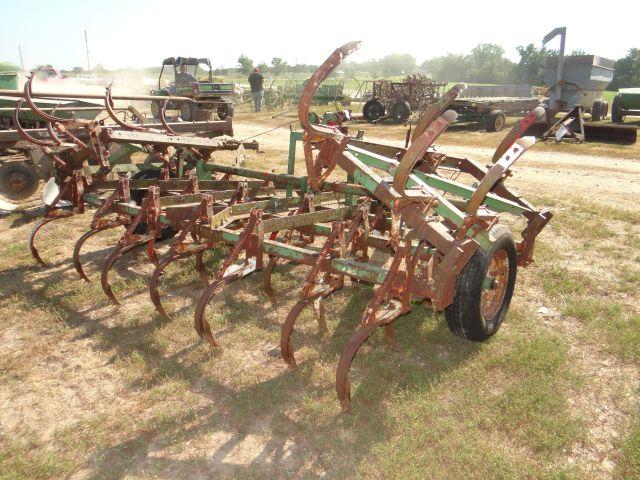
[{"x1": 444, "y1": 225, "x2": 518, "y2": 342}]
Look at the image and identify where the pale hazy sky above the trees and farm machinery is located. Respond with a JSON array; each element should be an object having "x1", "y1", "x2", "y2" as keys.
[{"x1": 0, "y1": 0, "x2": 640, "y2": 69}]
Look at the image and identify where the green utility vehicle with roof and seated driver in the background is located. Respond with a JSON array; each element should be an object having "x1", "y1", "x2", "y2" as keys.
[{"x1": 151, "y1": 57, "x2": 235, "y2": 122}]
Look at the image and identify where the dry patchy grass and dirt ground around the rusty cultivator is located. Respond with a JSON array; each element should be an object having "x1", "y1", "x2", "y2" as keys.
[{"x1": 0, "y1": 113, "x2": 640, "y2": 479}]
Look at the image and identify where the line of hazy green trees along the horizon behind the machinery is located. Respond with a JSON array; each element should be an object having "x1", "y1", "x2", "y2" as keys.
[{"x1": 234, "y1": 43, "x2": 640, "y2": 89}]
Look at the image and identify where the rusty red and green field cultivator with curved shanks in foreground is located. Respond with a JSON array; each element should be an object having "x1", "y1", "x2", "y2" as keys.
[{"x1": 12, "y1": 42, "x2": 551, "y2": 410}]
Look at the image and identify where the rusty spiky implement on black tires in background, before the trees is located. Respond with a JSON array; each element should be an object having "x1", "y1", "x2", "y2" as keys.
[{"x1": 356, "y1": 74, "x2": 447, "y2": 124}]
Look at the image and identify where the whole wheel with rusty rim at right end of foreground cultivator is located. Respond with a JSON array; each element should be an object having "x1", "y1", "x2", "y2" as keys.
[{"x1": 444, "y1": 225, "x2": 518, "y2": 342}]
